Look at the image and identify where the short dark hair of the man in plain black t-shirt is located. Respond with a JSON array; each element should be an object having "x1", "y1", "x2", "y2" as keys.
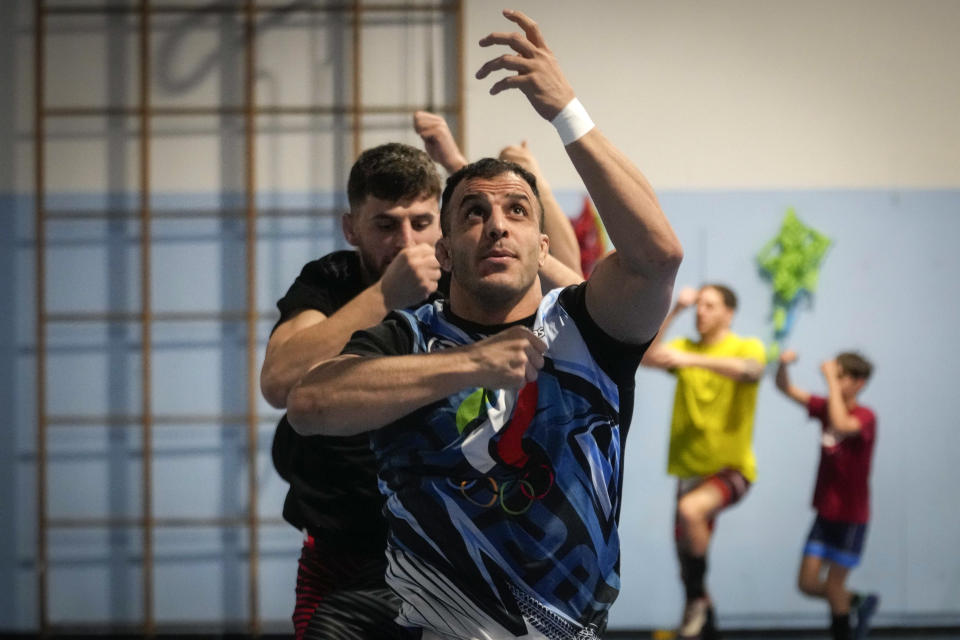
[{"x1": 347, "y1": 142, "x2": 440, "y2": 209}]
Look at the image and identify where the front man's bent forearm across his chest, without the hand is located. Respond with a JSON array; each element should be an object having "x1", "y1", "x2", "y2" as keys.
[{"x1": 287, "y1": 349, "x2": 477, "y2": 435}]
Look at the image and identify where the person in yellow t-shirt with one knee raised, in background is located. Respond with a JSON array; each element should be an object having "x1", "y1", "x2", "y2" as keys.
[{"x1": 643, "y1": 284, "x2": 765, "y2": 640}]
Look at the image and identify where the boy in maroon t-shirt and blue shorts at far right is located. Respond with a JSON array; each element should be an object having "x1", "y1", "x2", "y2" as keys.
[{"x1": 777, "y1": 350, "x2": 879, "y2": 640}]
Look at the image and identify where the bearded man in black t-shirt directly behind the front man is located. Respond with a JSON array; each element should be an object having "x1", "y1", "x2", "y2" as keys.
[{"x1": 260, "y1": 144, "x2": 441, "y2": 640}]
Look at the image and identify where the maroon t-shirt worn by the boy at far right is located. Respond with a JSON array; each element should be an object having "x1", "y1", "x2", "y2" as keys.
[{"x1": 807, "y1": 395, "x2": 877, "y2": 523}]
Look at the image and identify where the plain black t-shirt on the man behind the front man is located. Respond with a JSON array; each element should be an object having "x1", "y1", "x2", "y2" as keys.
[{"x1": 273, "y1": 251, "x2": 387, "y2": 553}]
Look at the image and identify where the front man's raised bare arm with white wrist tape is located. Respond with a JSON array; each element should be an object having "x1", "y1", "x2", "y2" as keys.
[{"x1": 477, "y1": 10, "x2": 683, "y2": 343}]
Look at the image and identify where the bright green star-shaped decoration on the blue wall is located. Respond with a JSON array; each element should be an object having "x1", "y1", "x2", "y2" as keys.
[{"x1": 757, "y1": 207, "x2": 831, "y2": 360}]
